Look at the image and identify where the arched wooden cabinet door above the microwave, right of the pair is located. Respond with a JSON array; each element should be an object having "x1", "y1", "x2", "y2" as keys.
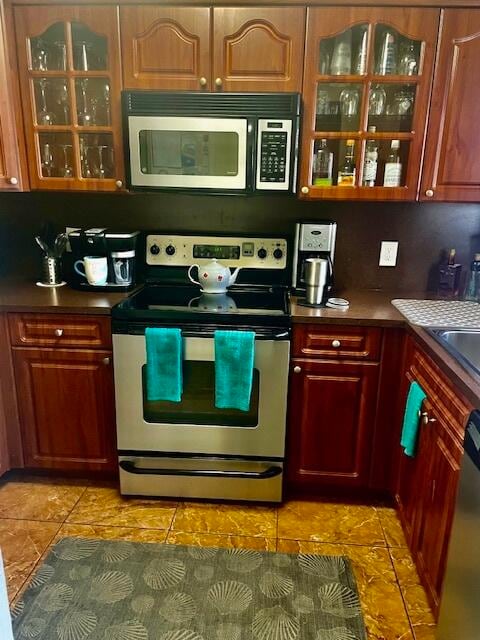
[{"x1": 213, "y1": 7, "x2": 305, "y2": 91}]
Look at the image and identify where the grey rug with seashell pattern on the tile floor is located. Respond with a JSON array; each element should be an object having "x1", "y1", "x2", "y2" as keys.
[{"x1": 12, "y1": 538, "x2": 366, "y2": 640}]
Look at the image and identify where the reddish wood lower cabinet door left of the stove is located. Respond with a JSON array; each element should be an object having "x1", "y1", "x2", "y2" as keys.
[{"x1": 12, "y1": 347, "x2": 116, "y2": 471}]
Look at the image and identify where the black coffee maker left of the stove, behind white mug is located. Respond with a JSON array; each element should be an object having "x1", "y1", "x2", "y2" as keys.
[{"x1": 68, "y1": 228, "x2": 140, "y2": 291}]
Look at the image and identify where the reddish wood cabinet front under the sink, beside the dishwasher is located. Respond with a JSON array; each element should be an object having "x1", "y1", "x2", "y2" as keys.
[{"x1": 396, "y1": 340, "x2": 471, "y2": 615}]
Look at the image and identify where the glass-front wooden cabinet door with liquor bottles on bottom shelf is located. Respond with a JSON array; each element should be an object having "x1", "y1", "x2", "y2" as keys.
[{"x1": 300, "y1": 7, "x2": 439, "y2": 200}]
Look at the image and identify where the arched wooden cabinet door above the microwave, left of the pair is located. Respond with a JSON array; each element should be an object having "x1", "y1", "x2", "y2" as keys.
[{"x1": 120, "y1": 5, "x2": 211, "y2": 91}]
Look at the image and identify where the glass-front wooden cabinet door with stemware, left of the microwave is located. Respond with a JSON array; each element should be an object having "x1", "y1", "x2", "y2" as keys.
[{"x1": 15, "y1": 6, "x2": 124, "y2": 191}]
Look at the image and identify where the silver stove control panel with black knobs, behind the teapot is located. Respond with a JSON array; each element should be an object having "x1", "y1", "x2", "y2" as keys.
[{"x1": 146, "y1": 234, "x2": 287, "y2": 269}]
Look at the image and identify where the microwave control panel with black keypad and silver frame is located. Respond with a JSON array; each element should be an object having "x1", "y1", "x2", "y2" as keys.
[{"x1": 255, "y1": 118, "x2": 292, "y2": 191}]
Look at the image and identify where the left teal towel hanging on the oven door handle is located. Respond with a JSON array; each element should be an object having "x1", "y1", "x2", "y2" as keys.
[{"x1": 145, "y1": 327, "x2": 183, "y2": 402}]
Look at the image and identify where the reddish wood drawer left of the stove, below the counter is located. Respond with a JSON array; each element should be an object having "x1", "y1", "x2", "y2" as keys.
[{"x1": 8, "y1": 313, "x2": 112, "y2": 349}]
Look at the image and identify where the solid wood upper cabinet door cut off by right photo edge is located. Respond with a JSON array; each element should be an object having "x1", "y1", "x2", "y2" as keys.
[{"x1": 421, "y1": 9, "x2": 480, "y2": 202}]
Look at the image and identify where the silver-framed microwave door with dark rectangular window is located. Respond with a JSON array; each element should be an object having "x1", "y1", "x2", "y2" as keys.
[{"x1": 128, "y1": 116, "x2": 248, "y2": 189}]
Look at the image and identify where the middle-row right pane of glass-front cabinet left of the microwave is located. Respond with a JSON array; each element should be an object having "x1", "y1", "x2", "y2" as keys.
[{"x1": 75, "y1": 78, "x2": 110, "y2": 127}]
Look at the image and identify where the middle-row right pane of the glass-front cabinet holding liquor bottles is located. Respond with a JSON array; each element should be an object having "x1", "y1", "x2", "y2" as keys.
[{"x1": 368, "y1": 84, "x2": 417, "y2": 132}]
